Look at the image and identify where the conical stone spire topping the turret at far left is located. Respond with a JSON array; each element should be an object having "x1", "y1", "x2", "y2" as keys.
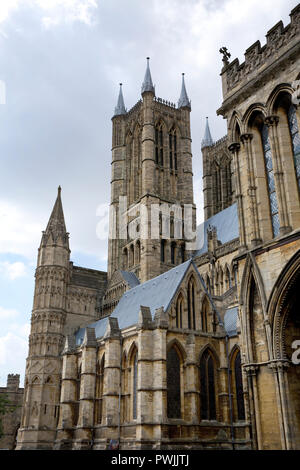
[{"x1": 42, "y1": 186, "x2": 68, "y2": 248}]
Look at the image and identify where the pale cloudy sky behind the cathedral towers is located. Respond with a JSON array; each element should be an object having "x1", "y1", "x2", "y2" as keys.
[{"x1": 0, "y1": 0, "x2": 298, "y2": 386}]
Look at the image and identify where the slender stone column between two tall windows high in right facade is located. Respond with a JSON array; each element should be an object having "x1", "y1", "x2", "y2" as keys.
[{"x1": 265, "y1": 115, "x2": 291, "y2": 235}]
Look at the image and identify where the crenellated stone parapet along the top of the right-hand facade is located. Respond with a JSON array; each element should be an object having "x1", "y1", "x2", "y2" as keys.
[{"x1": 222, "y1": 4, "x2": 300, "y2": 98}]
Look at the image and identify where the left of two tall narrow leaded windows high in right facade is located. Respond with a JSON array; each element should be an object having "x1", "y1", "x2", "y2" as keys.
[{"x1": 261, "y1": 124, "x2": 280, "y2": 237}]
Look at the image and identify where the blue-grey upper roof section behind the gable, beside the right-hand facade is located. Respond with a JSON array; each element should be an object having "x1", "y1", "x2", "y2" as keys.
[{"x1": 194, "y1": 202, "x2": 239, "y2": 257}]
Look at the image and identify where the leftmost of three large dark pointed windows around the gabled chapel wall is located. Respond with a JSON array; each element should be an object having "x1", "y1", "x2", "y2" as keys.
[{"x1": 167, "y1": 347, "x2": 181, "y2": 419}]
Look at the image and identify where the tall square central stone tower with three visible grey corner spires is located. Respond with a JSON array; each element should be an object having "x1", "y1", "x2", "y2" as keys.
[{"x1": 108, "y1": 58, "x2": 196, "y2": 282}]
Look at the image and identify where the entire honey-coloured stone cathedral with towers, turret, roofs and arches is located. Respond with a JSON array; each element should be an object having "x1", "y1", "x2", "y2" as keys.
[{"x1": 9, "y1": 5, "x2": 300, "y2": 450}]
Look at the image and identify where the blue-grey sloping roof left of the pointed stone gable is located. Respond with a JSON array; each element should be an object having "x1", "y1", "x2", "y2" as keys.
[{"x1": 75, "y1": 259, "x2": 192, "y2": 345}]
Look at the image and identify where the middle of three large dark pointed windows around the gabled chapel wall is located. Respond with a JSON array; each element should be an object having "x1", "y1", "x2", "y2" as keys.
[{"x1": 200, "y1": 350, "x2": 217, "y2": 420}]
